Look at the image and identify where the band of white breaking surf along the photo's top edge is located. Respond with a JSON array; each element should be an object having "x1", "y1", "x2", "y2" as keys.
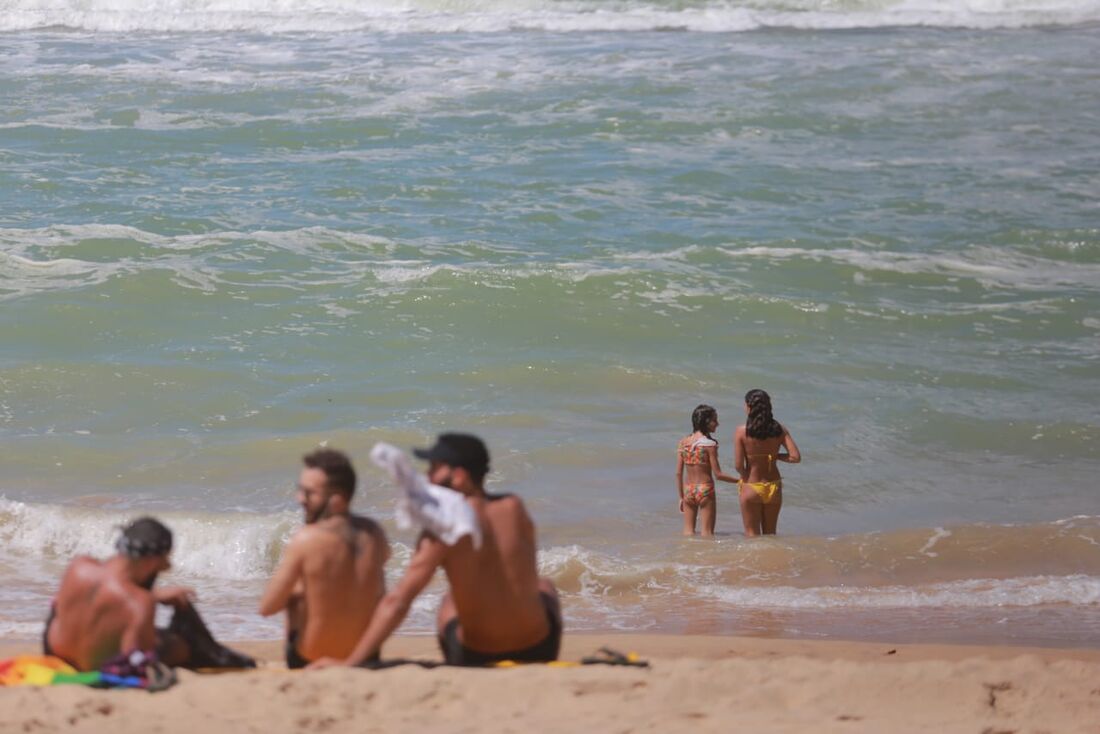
[{"x1": 0, "y1": 0, "x2": 1100, "y2": 33}]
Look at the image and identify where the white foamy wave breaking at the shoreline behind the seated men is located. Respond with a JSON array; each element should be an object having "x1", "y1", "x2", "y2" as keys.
[{"x1": 0, "y1": 497, "x2": 1100, "y2": 639}]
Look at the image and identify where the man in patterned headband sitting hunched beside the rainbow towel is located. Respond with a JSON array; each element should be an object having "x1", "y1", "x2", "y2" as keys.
[{"x1": 42, "y1": 517, "x2": 255, "y2": 670}]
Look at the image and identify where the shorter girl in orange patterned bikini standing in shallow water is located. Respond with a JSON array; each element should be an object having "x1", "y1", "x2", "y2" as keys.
[{"x1": 677, "y1": 405, "x2": 737, "y2": 538}]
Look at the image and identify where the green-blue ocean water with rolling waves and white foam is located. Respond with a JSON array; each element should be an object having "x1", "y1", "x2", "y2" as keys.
[{"x1": 0, "y1": 0, "x2": 1100, "y2": 646}]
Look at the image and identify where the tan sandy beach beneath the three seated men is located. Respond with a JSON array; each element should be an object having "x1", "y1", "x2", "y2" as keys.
[{"x1": 0, "y1": 634, "x2": 1100, "y2": 734}]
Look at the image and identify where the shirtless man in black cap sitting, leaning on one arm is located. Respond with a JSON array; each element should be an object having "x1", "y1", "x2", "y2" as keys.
[{"x1": 315, "y1": 434, "x2": 562, "y2": 667}]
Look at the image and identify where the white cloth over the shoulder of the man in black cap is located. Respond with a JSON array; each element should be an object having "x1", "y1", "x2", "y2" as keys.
[{"x1": 371, "y1": 441, "x2": 481, "y2": 548}]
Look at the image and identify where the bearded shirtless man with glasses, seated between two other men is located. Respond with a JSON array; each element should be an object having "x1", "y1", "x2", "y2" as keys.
[{"x1": 260, "y1": 449, "x2": 389, "y2": 668}]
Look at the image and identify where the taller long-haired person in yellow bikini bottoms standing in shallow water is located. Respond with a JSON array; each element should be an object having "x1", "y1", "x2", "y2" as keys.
[{"x1": 734, "y1": 390, "x2": 802, "y2": 537}]
